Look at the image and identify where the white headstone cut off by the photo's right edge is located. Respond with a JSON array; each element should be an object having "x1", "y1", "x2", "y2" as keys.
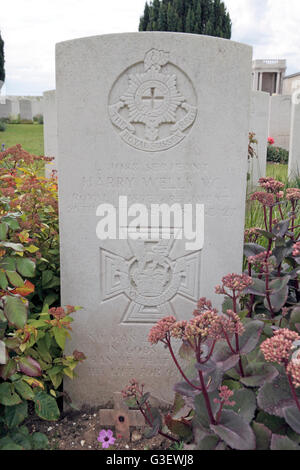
[{"x1": 289, "y1": 88, "x2": 300, "y2": 179}]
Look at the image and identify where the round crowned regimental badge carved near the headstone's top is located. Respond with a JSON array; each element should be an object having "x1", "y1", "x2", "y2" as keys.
[{"x1": 109, "y1": 49, "x2": 197, "y2": 152}]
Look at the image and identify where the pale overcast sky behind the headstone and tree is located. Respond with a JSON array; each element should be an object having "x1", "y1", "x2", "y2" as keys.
[{"x1": 0, "y1": 0, "x2": 300, "y2": 95}]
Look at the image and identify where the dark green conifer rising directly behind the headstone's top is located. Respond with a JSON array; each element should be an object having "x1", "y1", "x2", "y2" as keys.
[{"x1": 139, "y1": 0, "x2": 231, "y2": 39}]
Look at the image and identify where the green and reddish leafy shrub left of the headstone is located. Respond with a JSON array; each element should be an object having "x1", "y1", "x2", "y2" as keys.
[{"x1": 0, "y1": 146, "x2": 85, "y2": 449}]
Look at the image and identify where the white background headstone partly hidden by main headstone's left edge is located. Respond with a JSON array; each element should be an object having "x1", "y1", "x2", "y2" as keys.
[{"x1": 43, "y1": 90, "x2": 58, "y2": 177}]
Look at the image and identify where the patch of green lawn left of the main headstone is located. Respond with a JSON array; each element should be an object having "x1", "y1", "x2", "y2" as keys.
[{"x1": 0, "y1": 124, "x2": 44, "y2": 155}]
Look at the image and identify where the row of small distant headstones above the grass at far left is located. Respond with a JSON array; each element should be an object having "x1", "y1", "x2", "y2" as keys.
[{"x1": 0, "y1": 96, "x2": 44, "y2": 121}]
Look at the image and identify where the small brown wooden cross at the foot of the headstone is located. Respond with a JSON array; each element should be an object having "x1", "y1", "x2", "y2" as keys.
[{"x1": 99, "y1": 392, "x2": 146, "y2": 440}]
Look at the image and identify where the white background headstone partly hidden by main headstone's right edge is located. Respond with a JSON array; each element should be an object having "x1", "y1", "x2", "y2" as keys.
[{"x1": 248, "y1": 91, "x2": 270, "y2": 187}]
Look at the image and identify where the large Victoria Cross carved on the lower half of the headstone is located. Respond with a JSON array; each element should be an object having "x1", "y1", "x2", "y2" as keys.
[{"x1": 101, "y1": 238, "x2": 200, "y2": 323}]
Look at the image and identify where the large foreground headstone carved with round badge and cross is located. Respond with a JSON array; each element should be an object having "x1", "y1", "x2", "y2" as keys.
[{"x1": 56, "y1": 33, "x2": 252, "y2": 405}]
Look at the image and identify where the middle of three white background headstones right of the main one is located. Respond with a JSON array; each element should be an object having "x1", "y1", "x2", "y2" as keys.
[{"x1": 269, "y1": 95, "x2": 292, "y2": 150}]
